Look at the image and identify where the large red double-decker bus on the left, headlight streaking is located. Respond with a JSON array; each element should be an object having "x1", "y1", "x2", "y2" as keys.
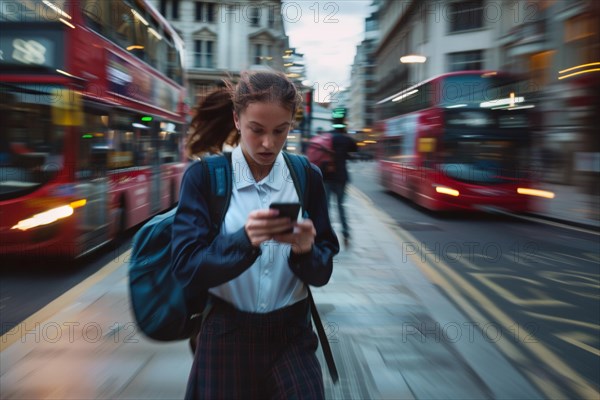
[{"x1": 0, "y1": 0, "x2": 187, "y2": 258}]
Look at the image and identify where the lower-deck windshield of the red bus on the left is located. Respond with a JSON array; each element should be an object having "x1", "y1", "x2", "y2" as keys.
[{"x1": 0, "y1": 83, "x2": 64, "y2": 199}]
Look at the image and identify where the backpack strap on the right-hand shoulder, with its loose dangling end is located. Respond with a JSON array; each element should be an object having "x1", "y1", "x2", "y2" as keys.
[{"x1": 283, "y1": 152, "x2": 339, "y2": 383}]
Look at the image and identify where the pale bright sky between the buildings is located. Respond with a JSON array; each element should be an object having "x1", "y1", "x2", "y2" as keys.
[{"x1": 281, "y1": 0, "x2": 371, "y2": 101}]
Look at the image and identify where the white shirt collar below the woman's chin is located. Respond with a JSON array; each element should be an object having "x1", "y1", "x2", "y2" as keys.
[{"x1": 231, "y1": 146, "x2": 289, "y2": 190}]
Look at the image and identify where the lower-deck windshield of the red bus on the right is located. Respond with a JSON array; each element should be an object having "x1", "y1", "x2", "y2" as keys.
[{"x1": 440, "y1": 140, "x2": 526, "y2": 184}]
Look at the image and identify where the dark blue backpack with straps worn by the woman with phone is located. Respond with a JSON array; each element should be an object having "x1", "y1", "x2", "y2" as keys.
[{"x1": 129, "y1": 152, "x2": 339, "y2": 383}]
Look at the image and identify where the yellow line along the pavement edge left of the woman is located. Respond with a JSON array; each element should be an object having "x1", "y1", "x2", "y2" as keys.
[{"x1": 0, "y1": 250, "x2": 131, "y2": 352}]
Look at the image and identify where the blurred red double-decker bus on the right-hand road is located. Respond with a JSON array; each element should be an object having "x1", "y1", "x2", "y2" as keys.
[{"x1": 376, "y1": 71, "x2": 552, "y2": 212}]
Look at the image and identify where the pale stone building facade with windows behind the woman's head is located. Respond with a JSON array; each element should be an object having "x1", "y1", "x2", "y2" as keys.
[{"x1": 150, "y1": 0, "x2": 288, "y2": 104}]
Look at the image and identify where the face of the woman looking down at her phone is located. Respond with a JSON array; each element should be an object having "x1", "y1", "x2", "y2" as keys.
[{"x1": 233, "y1": 103, "x2": 292, "y2": 166}]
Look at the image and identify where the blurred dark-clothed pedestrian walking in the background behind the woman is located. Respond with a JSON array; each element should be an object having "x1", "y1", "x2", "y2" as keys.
[{"x1": 323, "y1": 128, "x2": 358, "y2": 248}]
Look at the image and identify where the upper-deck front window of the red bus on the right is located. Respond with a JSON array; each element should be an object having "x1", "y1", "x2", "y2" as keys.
[{"x1": 440, "y1": 75, "x2": 525, "y2": 108}]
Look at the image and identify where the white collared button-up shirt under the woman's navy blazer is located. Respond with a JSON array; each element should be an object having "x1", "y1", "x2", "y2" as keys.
[{"x1": 210, "y1": 146, "x2": 307, "y2": 313}]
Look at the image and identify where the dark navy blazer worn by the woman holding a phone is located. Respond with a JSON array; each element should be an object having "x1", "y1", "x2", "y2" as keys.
[{"x1": 171, "y1": 158, "x2": 340, "y2": 304}]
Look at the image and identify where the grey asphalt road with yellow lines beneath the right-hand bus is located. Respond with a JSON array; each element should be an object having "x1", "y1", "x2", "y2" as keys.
[{"x1": 350, "y1": 162, "x2": 600, "y2": 398}]
